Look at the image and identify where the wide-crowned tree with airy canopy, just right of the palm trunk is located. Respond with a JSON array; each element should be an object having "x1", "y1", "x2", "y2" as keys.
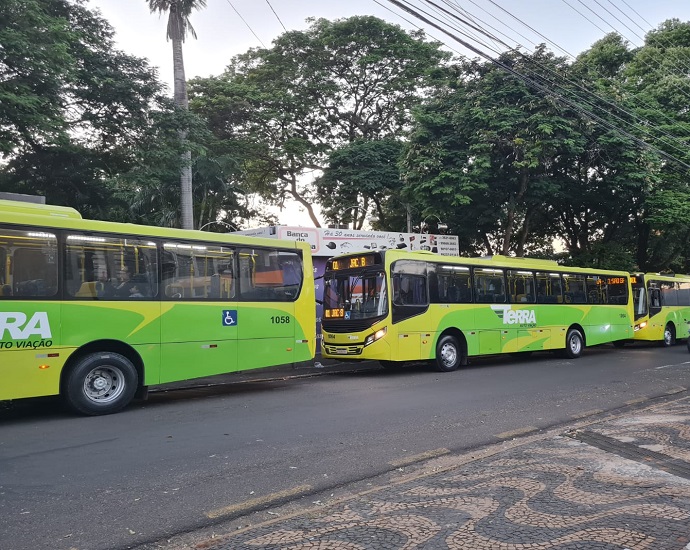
[{"x1": 190, "y1": 16, "x2": 448, "y2": 226}]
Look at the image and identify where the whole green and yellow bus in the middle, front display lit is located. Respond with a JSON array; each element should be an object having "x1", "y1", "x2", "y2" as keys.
[{"x1": 321, "y1": 250, "x2": 633, "y2": 371}]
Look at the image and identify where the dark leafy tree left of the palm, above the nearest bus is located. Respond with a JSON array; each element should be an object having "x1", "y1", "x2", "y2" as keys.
[{"x1": 0, "y1": 0, "x2": 165, "y2": 219}]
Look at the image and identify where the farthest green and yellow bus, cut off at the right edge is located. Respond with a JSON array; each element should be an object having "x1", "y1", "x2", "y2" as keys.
[{"x1": 630, "y1": 273, "x2": 690, "y2": 346}]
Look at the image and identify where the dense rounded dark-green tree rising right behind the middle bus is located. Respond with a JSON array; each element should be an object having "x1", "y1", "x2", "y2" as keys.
[{"x1": 404, "y1": 48, "x2": 582, "y2": 255}]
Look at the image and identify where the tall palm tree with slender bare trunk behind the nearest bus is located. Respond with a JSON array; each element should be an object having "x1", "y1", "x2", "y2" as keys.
[{"x1": 146, "y1": 0, "x2": 206, "y2": 229}]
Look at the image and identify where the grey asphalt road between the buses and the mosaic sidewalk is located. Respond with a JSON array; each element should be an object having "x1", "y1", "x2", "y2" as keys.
[{"x1": 0, "y1": 345, "x2": 690, "y2": 550}]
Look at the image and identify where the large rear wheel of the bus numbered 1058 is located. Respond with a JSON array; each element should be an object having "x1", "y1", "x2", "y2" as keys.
[{"x1": 63, "y1": 352, "x2": 139, "y2": 416}]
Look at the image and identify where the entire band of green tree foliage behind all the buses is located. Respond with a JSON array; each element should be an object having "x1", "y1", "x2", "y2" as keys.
[{"x1": 0, "y1": 0, "x2": 690, "y2": 272}]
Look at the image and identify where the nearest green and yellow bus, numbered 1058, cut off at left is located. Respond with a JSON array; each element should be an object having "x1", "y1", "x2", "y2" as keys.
[{"x1": 0, "y1": 200, "x2": 316, "y2": 415}]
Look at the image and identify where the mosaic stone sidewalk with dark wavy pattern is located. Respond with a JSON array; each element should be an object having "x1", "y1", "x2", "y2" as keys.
[{"x1": 195, "y1": 397, "x2": 690, "y2": 550}]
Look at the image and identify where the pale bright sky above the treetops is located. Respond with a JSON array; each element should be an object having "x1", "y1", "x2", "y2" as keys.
[{"x1": 88, "y1": 0, "x2": 690, "y2": 225}]
